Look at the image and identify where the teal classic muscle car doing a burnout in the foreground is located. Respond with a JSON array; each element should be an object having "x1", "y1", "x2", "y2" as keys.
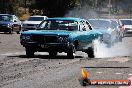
[{"x1": 20, "y1": 17, "x2": 102, "y2": 58}]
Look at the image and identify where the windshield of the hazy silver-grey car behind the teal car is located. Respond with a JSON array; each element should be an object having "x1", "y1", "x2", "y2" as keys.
[{"x1": 89, "y1": 20, "x2": 117, "y2": 29}]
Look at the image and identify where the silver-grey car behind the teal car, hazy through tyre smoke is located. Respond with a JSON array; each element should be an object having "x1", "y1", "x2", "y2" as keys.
[{"x1": 88, "y1": 19, "x2": 122, "y2": 47}]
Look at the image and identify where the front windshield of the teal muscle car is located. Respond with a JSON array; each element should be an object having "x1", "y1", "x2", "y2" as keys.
[{"x1": 38, "y1": 20, "x2": 78, "y2": 31}]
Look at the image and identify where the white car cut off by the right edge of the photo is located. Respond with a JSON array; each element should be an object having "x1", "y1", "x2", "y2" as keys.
[{"x1": 119, "y1": 19, "x2": 132, "y2": 37}]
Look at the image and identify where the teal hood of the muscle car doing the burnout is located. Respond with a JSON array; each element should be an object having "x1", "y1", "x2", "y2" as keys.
[{"x1": 21, "y1": 30, "x2": 72, "y2": 35}]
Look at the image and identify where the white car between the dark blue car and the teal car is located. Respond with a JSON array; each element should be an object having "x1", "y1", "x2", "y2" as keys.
[{"x1": 22, "y1": 15, "x2": 48, "y2": 31}]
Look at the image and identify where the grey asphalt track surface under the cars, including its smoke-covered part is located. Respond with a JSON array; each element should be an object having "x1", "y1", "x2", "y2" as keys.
[{"x1": 0, "y1": 33, "x2": 132, "y2": 88}]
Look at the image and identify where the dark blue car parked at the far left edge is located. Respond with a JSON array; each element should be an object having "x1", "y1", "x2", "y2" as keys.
[{"x1": 0, "y1": 14, "x2": 21, "y2": 34}]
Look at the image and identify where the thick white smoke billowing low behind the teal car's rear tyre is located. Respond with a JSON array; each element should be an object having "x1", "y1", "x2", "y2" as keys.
[{"x1": 94, "y1": 40, "x2": 132, "y2": 58}]
